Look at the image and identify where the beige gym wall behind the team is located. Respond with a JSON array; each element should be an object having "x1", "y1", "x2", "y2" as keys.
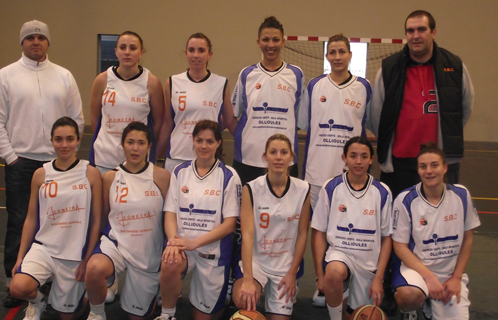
[{"x1": 0, "y1": 0, "x2": 498, "y2": 142}]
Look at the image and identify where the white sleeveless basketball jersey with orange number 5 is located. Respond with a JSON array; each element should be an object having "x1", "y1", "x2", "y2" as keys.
[{"x1": 167, "y1": 72, "x2": 230, "y2": 160}]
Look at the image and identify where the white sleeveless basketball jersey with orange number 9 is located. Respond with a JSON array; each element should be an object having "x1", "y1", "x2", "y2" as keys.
[{"x1": 247, "y1": 175, "x2": 310, "y2": 276}]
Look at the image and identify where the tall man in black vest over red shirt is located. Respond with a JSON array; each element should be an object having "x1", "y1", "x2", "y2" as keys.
[{"x1": 369, "y1": 10, "x2": 474, "y2": 198}]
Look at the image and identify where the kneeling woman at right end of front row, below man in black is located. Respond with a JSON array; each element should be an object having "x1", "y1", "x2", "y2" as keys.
[{"x1": 392, "y1": 142, "x2": 480, "y2": 320}]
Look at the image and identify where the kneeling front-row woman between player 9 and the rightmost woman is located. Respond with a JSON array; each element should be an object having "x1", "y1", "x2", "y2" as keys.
[{"x1": 311, "y1": 137, "x2": 392, "y2": 320}]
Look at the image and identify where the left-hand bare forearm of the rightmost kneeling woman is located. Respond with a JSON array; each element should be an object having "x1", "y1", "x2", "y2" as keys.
[{"x1": 393, "y1": 240, "x2": 444, "y2": 301}]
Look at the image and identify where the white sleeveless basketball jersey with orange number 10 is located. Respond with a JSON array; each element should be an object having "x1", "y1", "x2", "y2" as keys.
[{"x1": 34, "y1": 160, "x2": 92, "y2": 261}]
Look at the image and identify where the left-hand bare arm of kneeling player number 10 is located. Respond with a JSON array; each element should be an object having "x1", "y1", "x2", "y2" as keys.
[{"x1": 12, "y1": 167, "x2": 45, "y2": 275}]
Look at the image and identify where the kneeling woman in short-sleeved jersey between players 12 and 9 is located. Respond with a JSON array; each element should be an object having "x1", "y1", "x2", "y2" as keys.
[{"x1": 156, "y1": 120, "x2": 242, "y2": 320}]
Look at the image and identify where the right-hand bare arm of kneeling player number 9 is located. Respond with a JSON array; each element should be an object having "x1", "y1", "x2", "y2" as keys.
[{"x1": 278, "y1": 193, "x2": 310, "y2": 302}]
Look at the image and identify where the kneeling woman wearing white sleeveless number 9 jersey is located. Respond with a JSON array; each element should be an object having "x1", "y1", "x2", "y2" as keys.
[{"x1": 233, "y1": 134, "x2": 310, "y2": 320}]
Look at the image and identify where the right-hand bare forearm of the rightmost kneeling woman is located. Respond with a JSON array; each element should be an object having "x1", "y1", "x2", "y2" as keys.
[{"x1": 443, "y1": 230, "x2": 474, "y2": 304}]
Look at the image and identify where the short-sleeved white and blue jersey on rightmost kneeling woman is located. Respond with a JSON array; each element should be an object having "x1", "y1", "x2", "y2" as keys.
[{"x1": 392, "y1": 183, "x2": 481, "y2": 277}]
